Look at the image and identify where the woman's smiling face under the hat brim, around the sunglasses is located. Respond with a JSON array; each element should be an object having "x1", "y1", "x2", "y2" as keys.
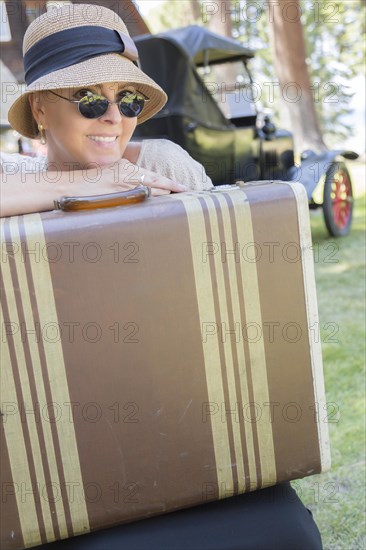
[{"x1": 30, "y1": 83, "x2": 137, "y2": 170}]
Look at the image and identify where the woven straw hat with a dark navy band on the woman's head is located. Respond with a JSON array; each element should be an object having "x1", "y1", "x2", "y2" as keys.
[{"x1": 8, "y1": 4, "x2": 167, "y2": 138}]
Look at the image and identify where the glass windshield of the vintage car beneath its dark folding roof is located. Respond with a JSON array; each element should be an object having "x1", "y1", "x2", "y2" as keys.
[{"x1": 197, "y1": 61, "x2": 256, "y2": 119}]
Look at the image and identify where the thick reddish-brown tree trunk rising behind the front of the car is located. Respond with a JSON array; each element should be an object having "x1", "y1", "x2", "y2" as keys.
[{"x1": 268, "y1": 0, "x2": 327, "y2": 153}]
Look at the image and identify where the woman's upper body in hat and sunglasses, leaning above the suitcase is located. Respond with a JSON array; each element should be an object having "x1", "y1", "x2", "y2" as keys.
[{"x1": 1, "y1": 5, "x2": 212, "y2": 220}]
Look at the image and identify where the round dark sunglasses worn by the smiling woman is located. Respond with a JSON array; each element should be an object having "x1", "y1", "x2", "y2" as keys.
[{"x1": 48, "y1": 90, "x2": 149, "y2": 118}]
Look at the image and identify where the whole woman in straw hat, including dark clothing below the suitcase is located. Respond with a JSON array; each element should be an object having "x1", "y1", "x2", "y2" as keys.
[{"x1": 2, "y1": 5, "x2": 321, "y2": 550}]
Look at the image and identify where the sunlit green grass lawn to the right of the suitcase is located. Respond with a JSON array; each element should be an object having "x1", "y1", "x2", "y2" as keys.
[{"x1": 293, "y1": 162, "x2": 366, "y2": 550}]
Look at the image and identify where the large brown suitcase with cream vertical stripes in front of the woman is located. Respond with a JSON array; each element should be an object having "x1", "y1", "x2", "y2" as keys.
[{"x1": 1, "y1": 182, "x2": 330, "y2": 549}]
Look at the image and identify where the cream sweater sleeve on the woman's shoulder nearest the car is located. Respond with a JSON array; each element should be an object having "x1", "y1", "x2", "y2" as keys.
[{"x1": 136, "y1": 139, "x2": 213, "y2": 191}]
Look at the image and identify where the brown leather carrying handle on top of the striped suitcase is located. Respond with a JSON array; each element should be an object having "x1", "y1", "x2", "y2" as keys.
[{"x1": 54, "y1": 185, "x2": 151, "y2": 212}]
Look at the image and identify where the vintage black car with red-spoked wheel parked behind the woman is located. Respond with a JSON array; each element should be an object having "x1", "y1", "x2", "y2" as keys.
[{"x1": 134, "y1": 25, "x2": 358, "y2": 237}]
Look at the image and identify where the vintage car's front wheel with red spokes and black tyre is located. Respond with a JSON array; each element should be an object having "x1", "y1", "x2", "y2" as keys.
[{"x1": 323, "y1": 162, "x2": 353, "y2": 237}]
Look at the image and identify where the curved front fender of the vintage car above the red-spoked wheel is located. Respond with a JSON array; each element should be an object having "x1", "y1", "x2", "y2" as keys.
[{"x1": 286, "y1": 150, "x2": 359, "y2": 204}]
